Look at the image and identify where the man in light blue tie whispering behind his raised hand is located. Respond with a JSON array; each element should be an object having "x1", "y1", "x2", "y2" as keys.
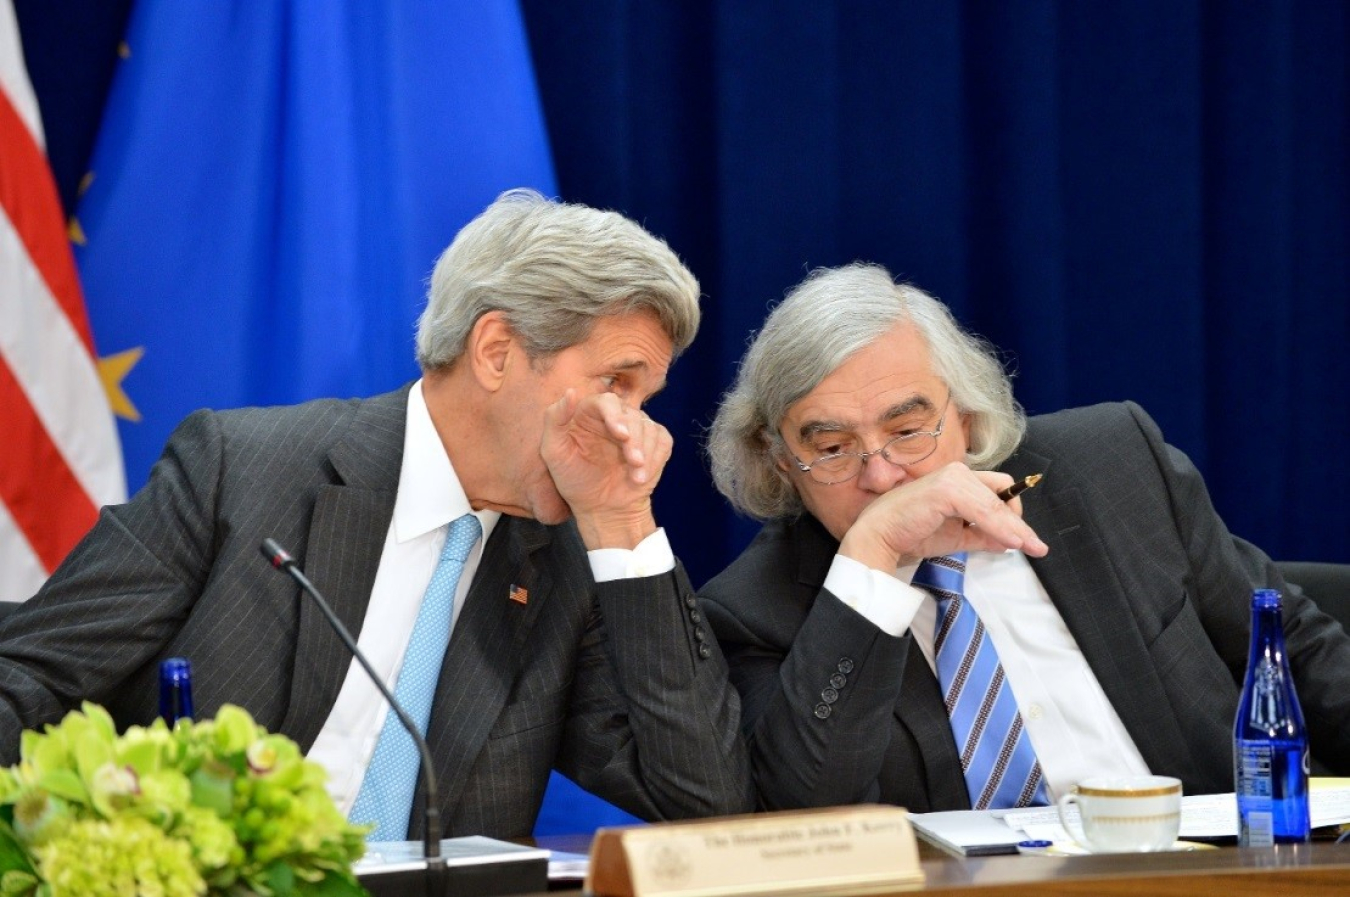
[{"x1": 0, "y1": 190, "x2": 753, "y2": 840}]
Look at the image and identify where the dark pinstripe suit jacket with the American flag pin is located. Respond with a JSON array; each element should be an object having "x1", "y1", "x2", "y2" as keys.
[{"x1": 0, "y1": 386, "x2": 752, "y2": 838}]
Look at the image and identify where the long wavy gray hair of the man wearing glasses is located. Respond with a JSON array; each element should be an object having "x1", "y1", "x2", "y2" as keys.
[{"x1": 706, "y1": 263, "x2": 1026, "y2": 520}]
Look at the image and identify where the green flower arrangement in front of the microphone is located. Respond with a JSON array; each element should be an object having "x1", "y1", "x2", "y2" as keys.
[{"x1": 0, "y1": 704, "x2": 366, "y2": 897}]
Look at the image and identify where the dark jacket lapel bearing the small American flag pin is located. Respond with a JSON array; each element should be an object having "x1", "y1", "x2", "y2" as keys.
[{"x1": 413, "y1": 516, "x2": 555, "y2": 820}]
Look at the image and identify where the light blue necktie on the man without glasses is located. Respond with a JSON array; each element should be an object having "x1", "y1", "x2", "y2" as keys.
[{"x1": 350, "y1": 513, "x2": 482, "y2": 840}]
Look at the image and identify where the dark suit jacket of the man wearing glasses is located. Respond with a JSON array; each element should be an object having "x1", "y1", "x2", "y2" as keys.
[{"x1": 701, "y1": 404, "x2": 1350, "y2": 812}]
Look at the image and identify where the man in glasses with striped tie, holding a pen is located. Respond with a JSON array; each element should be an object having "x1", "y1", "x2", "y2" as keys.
[{"x1": 701, "y1": 265, "x2": 1350, "y2": 812}]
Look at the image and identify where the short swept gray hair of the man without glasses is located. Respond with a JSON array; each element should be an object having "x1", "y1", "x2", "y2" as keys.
[{"x1": 417, "y1": 189, "x2": 699, "y2": 371}]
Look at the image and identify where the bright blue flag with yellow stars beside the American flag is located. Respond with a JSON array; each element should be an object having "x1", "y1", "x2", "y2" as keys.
[{"x1": 77, "y1": 0, "x2": 556, "y2": 489}]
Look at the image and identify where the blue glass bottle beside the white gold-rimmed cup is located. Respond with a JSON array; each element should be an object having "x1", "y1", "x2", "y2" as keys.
[{"x1": 1233, "y1": 589, "x2": 1312, "y2": 847}]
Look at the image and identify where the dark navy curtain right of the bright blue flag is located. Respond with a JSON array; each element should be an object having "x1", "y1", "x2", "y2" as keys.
[{"x1": 524, "y1": 0, "x2": 1350, "y2": 581}]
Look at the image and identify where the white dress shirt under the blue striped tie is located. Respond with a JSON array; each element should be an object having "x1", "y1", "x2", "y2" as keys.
[{"x1": 825, "y1": 551, "x2": 1149, "y2": 800}]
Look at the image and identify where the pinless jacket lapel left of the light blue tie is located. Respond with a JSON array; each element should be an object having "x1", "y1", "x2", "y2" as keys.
[{"x1": 272, "y1": 386, "x2": 408, "y2": 751}]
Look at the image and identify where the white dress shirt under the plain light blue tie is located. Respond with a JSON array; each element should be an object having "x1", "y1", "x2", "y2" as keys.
[{"x1": 309, "y1": 381, "x2": 675, "y2": 815}]
